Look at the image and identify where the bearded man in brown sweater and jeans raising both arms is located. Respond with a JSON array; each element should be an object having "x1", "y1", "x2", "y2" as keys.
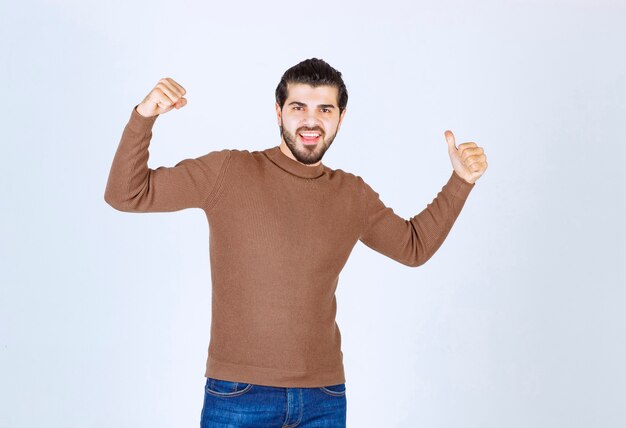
[{"x1": 104, "y1": 58, "x2": 487, "y2": 427}]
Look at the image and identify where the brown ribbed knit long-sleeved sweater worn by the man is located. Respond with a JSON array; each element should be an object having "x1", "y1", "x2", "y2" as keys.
[{"x1": 104, "y1": 106, "x2": 475, "y2": 388}]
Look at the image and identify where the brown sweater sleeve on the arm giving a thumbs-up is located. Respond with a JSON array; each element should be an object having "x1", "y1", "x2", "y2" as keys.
[{"x1": 359, "y1": 170, "x2": 475, "y2": 267}]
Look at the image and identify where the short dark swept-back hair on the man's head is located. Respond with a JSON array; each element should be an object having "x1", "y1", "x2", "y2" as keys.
[{"x1": 276, "y1": 58, "x2": 348, "y2": 115}]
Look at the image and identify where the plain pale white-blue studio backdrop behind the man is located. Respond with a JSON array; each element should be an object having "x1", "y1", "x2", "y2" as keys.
[{"x1": 0, "y1": 0, "x2": 626, "y2": 428}]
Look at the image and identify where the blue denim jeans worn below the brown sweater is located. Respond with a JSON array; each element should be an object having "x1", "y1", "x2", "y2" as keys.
[{"x1": 200, "y1": 377, "x2": 346, "y2": 428}]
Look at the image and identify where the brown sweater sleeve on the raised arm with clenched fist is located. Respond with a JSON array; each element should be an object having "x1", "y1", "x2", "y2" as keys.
[{"x1": 104, "y1": 106, "x2": 230, "y2": 212}]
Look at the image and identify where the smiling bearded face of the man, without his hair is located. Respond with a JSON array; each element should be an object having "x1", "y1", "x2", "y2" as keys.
[{"x1": 276, "y1": 83, "x2": 346, "y2": 166}]
